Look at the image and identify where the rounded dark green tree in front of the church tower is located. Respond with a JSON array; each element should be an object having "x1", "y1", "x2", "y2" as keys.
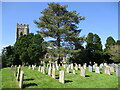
[{"x1": 14, "y1": 33, "x2": 45, "y2": 64}]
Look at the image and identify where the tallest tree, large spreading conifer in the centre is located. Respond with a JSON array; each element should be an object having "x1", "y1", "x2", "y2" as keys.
[{"x1": 34, "y1": 3, "x2": 85, "y2": 63}]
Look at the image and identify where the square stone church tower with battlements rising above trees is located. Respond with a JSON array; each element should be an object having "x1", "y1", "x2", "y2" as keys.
[{"x1": 16, "y1": 23, "x2": 29, "y2": 39}]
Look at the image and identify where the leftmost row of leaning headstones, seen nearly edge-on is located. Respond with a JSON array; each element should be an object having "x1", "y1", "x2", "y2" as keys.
[{"x1": 11, "y1": 65, "x2": 24, "y2": 88}]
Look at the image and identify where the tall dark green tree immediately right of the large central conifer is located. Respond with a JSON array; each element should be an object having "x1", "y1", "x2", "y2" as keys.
[{"x1": 85, "y1": 33, "x2": 103, "y2": 64}]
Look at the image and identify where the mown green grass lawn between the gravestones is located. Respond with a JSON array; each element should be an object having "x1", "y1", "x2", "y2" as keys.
[{"x1": 2, "y1": 67, "x2": 118, "y2": 89}]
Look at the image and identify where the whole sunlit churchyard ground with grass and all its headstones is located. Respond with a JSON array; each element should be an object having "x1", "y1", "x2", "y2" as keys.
[{"x1": 1, "y1": 63, "x2": 120, "y2": 89}]
